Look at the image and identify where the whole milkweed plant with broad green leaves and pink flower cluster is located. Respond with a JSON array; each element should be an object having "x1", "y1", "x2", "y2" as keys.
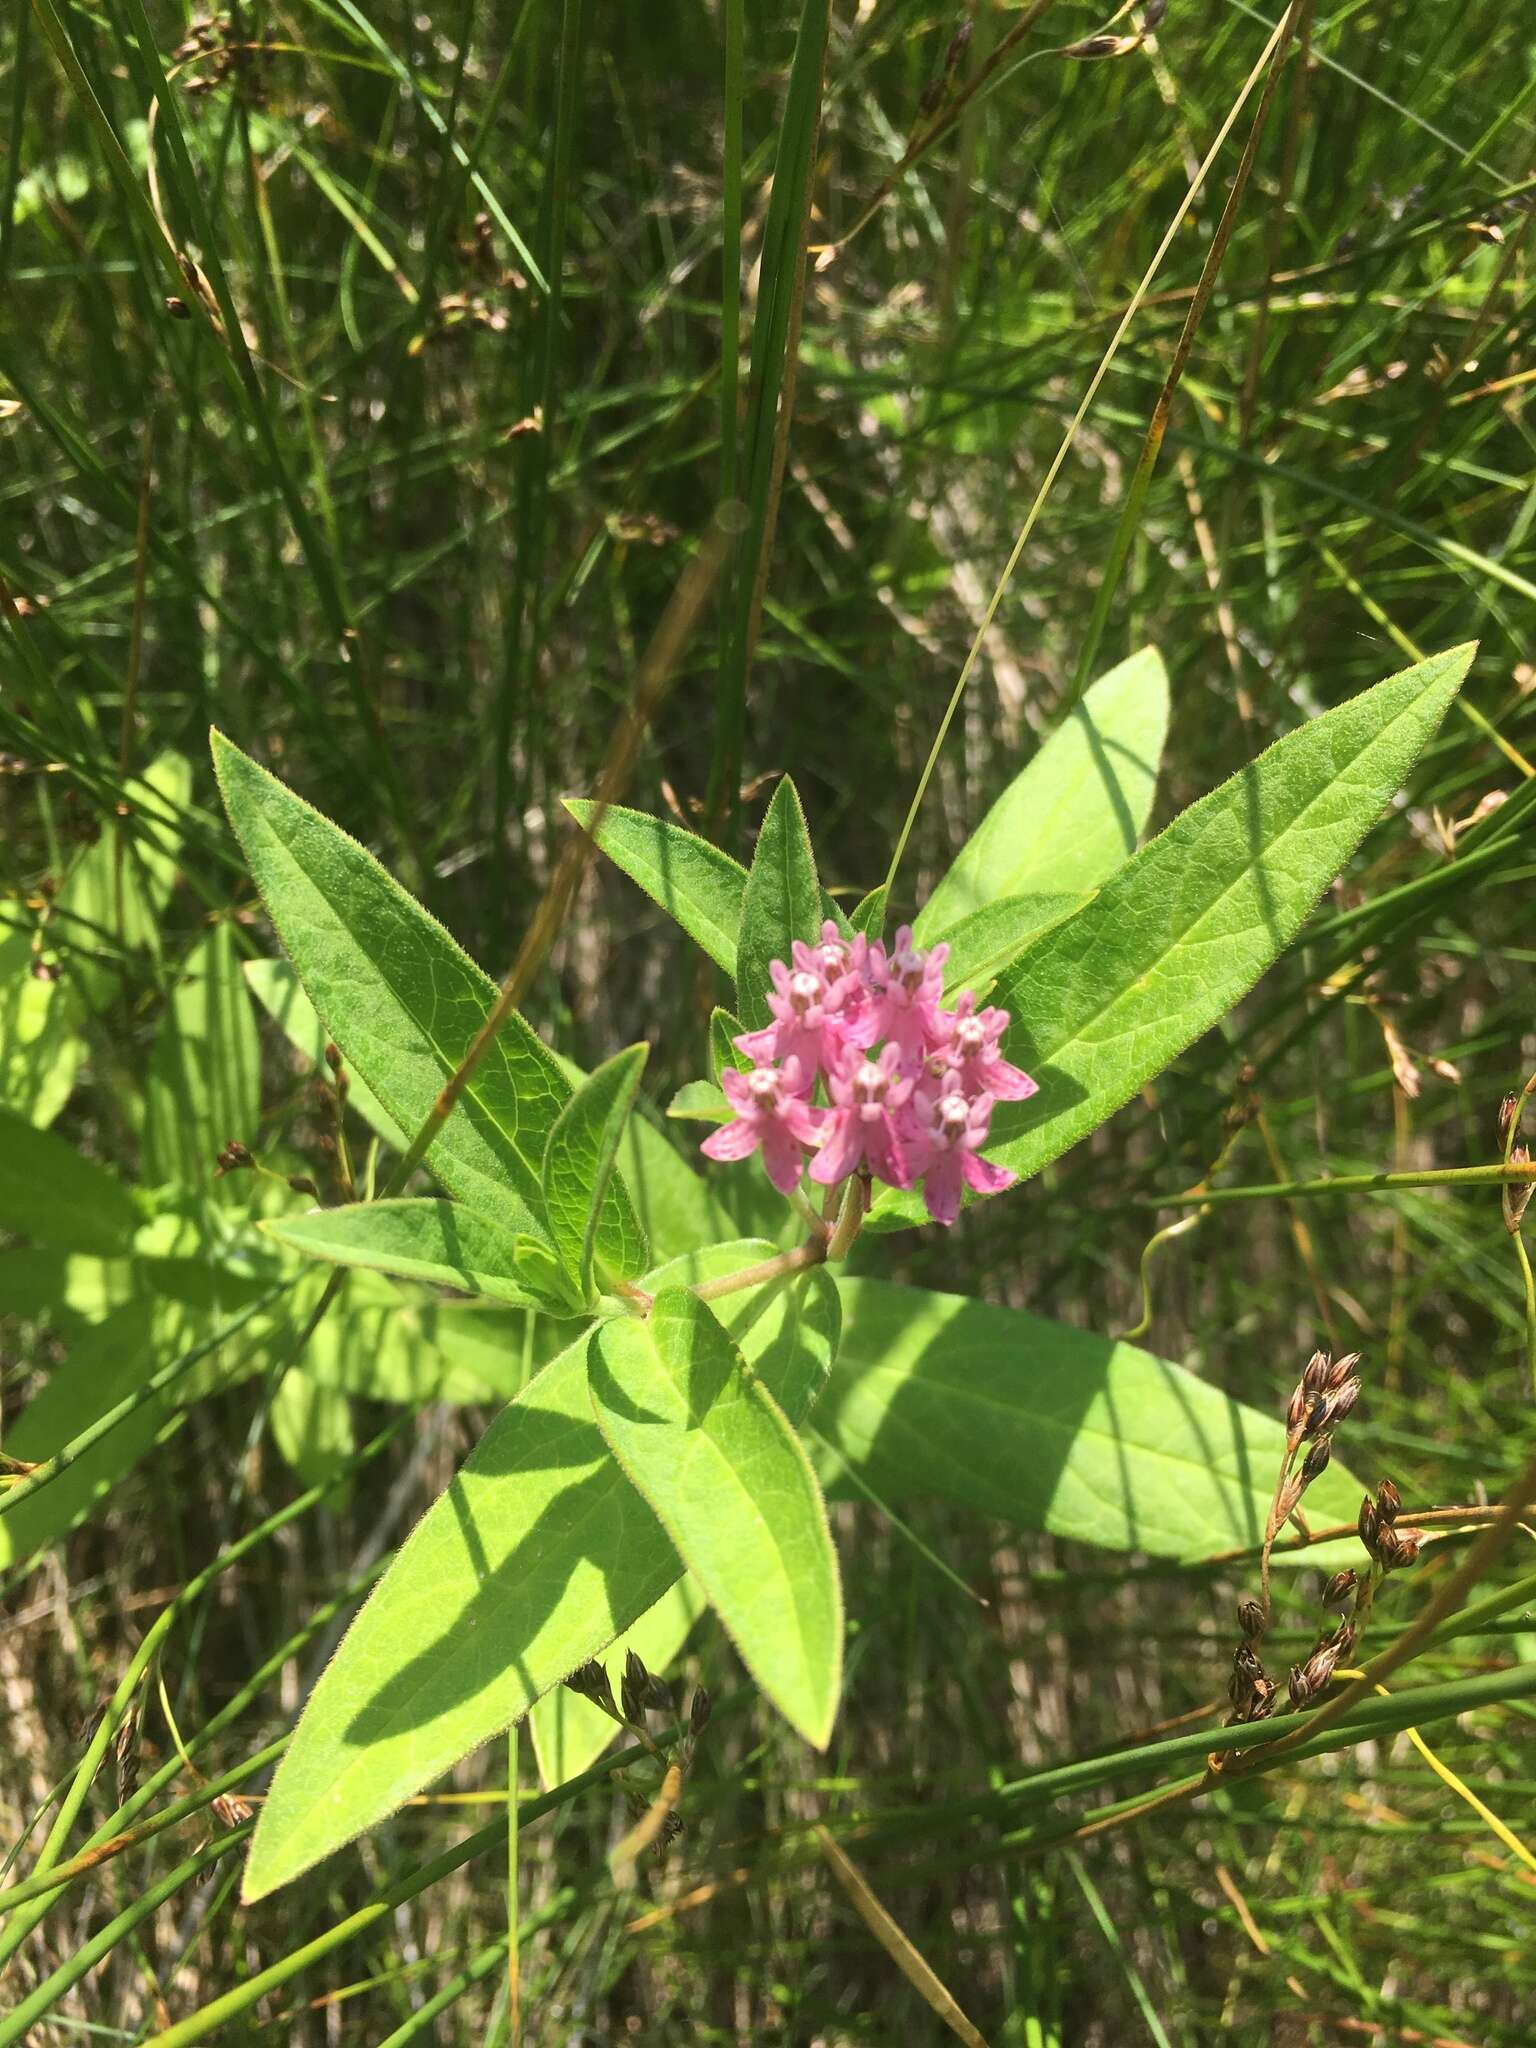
[{"x1": 9, "y1": 647, "x2": 1473, "y2": 1898}]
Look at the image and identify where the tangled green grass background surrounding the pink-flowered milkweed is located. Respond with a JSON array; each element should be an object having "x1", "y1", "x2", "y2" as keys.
[{"x1": 0, "y1": 0, "x2": 1536, "y2": 2048}]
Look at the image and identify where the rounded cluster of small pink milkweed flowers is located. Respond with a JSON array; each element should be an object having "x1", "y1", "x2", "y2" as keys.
[{"x1": 705, "y1": 920, "x2": 1036, "y2": 1223}]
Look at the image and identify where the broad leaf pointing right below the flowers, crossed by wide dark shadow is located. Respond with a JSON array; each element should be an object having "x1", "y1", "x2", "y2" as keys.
[{"x1": 817, "y1": 1278, "x2": 1362, "y2": 1565}]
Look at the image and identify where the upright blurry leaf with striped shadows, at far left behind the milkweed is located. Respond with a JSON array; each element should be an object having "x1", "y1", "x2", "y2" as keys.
[{"x1": 143, "y1": 924, "x2": 260, "y2": 1202}]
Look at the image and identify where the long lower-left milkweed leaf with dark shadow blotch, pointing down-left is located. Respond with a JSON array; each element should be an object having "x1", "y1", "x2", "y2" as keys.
[{"x1": 244, "y1": 1243, "x2": 838, "y2": 1898}]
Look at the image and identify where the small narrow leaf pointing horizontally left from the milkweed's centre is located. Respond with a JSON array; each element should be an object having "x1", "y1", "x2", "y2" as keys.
[{"x1": 262, "y1": 1196, "x2": 539, "y2": 1309}]
